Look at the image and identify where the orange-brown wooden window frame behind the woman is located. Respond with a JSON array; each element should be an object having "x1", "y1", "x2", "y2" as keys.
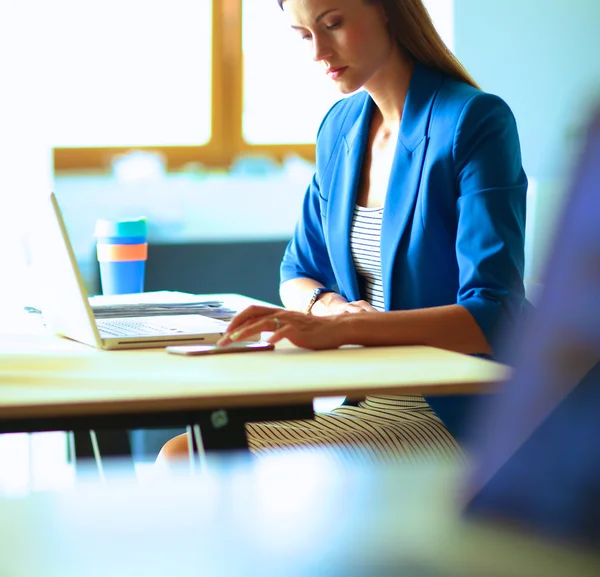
[{"x1": 53, "y1": 0, "x2": 315, "y2": 172}]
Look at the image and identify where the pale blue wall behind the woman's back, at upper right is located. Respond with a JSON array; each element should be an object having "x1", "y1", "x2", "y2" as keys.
[{"x1": 454, "y1": 0, "x2": 600, "y2": 277}]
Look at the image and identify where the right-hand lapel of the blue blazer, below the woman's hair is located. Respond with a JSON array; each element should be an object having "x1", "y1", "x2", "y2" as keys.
[{"x1": 381, "y1": 63, "x2": 442, "y2": 310}]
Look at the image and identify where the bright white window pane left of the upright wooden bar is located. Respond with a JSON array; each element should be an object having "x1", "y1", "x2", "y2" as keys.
[{"x1": 48, "y1": 0, "x2": 212, "y2": 148}]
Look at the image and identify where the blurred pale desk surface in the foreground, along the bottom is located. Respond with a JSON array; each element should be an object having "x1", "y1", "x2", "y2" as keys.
[{"x1": 0, "y1": 454, "x2": 600, "y2": 577}]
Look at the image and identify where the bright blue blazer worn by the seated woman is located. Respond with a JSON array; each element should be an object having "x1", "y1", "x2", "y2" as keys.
[{"x1": 281, "y1": 63, "x2": 527, "y2": 436}]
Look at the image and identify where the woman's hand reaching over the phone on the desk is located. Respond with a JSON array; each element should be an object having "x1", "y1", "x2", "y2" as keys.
[{"x1": 218, "y1": 306, "x2": 347, "y2": 350}]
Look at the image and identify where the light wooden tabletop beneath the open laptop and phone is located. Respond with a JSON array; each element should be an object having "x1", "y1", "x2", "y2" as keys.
[{"x1": 0, "y1": 295, "x2": 510, "y2": 419}]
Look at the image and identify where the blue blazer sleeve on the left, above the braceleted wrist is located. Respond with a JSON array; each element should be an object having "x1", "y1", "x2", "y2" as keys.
[{"x1": 280, "y1": 102, "x2": 340, "y2": 290}]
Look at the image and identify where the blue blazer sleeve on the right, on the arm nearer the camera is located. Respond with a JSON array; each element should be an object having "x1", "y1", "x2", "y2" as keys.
[{"x1": 453, "y1": 93, "x2": 527, "y2": 352}]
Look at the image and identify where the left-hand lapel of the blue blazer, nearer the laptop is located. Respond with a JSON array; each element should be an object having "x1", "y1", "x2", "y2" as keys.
[{"x1": 327, "y1": 95, "x2": 373, "y2": 301}]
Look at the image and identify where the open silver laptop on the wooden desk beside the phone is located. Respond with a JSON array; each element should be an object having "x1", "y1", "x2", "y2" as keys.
[{"x1": 31, "y1": 193, "x2": 234, "y2": 350}]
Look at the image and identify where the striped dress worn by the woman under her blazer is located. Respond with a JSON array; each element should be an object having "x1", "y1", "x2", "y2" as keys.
[{"x1": 246, "y1": 205, "x2": 464, "y2": 463}]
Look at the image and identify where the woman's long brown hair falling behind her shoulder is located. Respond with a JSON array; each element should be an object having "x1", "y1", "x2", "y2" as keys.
[{"x1": 277, "y1": 0, "x2": 479, "y2": 88}]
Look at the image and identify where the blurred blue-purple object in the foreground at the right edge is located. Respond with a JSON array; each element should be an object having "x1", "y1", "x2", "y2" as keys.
[{"x1": 466, "y1": 108, "x2": 600, "y2": 548}]
